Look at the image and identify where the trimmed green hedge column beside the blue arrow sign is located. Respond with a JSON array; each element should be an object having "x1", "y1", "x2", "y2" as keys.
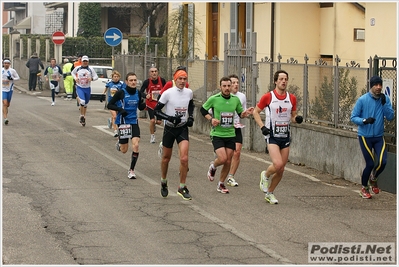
[{"x1": 77, "y1": 2, "x2": 102, "y2": 38}]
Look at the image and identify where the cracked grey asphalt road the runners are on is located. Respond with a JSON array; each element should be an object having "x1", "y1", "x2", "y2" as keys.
[{"x1": 2, "y1": 84, "x2": 397, "y2": 265}]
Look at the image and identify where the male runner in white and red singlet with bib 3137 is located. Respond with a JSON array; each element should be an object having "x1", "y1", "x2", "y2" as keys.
[{"x1": 253, "y1": 70, "x2": 303, "y2": 204}]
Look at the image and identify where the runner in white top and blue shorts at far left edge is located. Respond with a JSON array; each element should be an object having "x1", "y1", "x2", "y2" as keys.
[{"x1": 1, "y1": 59, "x2": 20, "y2": 125}]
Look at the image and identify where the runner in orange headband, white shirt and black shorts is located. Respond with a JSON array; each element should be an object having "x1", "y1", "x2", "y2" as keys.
[{"x1": 154, "y1": 70, "x2": 194, "y2": 200}]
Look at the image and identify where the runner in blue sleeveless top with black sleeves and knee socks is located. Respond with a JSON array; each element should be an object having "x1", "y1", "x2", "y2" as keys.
[{"x1": 107, "y1": 72, "x2": 145, "y2": 179}]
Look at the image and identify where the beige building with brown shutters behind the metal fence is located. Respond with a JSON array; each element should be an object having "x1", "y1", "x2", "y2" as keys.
[{"x1": 169, "y1": 2, "x2": 398, "y2": 67}]
